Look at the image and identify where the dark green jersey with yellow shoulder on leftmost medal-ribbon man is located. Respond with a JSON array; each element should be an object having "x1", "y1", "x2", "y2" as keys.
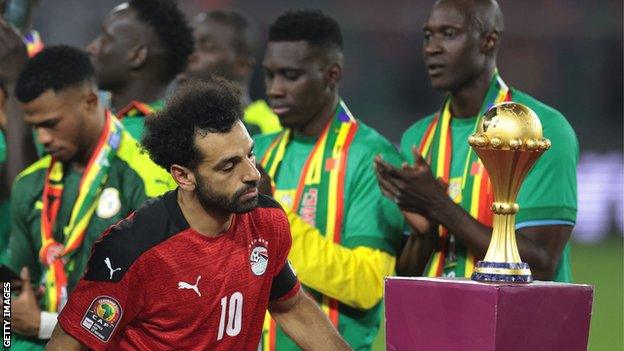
[{"x1": 6, "y1": 131, "x2": 175, "y2": 350}]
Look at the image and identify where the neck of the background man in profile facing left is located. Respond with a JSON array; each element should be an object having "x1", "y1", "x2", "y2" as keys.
[{"x1": 111, "y1": 80, "x2": 168, "y2": 111}]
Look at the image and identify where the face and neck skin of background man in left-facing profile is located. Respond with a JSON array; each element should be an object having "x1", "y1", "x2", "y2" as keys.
[{"x1": 87, "y1": 4, "x2": 171, "y2": 111}]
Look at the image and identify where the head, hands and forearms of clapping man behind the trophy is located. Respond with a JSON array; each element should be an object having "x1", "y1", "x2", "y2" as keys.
[{"x1": 375, "y1": 1, "x2": 572, "y2": 280}]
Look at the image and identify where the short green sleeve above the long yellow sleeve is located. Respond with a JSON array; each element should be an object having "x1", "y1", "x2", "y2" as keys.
[{"x1": 342, "y1": 143, "x2": 403, "y2": 256}]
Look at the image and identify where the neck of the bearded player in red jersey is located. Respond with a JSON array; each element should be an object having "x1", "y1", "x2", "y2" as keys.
[{"x1": 178, "y1": 188, "x2": 234, "y2": 237}]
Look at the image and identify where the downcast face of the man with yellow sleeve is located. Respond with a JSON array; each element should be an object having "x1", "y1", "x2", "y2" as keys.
[{"x1": 262, "y1": 41, "x2": 342, "y2": 136}]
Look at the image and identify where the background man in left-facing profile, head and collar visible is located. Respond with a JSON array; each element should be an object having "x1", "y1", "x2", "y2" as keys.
[{"x1": 87, "y1": 0, "x2": 193, "y2": 140}]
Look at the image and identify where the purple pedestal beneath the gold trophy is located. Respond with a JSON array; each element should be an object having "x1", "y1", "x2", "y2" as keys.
[{"x1": 385, "y1": 278, "x2": 593, "y2": 351}]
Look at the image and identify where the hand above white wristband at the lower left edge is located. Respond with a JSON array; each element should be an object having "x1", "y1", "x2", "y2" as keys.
[{"x1": 11, "y1": 267, "x2": 41, "y2": 337}]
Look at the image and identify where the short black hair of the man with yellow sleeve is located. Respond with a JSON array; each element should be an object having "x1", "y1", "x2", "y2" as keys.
[{"x1": 269, "y1": 10, "x2": 342, "y2": 50}]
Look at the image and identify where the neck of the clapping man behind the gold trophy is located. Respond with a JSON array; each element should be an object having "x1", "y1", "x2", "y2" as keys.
[{"x1": 450, "y1": 65, "x2": 495, "y2": 118}]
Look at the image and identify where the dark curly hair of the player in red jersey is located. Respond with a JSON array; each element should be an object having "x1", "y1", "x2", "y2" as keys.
[{"x1": 143, "y1": 78, "x2": 243, "y2": 170}]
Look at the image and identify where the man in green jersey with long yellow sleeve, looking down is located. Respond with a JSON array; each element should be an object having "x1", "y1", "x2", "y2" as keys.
[{"x1": 256, "y1": 10, "x2": 403, "y2": 350}]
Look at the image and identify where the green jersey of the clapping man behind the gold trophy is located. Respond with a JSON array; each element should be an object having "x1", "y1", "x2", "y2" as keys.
[{"x1": 401, "y1": 89, "x2": 579, "y2": 282}]
